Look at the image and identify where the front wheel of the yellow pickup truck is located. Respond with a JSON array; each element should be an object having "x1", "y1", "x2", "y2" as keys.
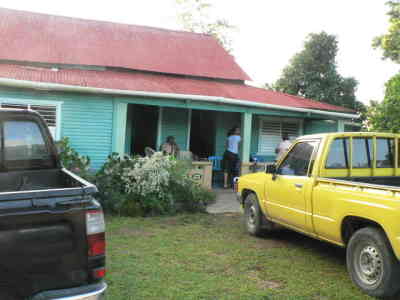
[{"x1": 244, "y1": 193, "x2": 273, "y2": 236}]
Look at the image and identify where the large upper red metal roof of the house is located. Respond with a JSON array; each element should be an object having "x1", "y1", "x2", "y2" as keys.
[{"x1": 0, "y1": 8, "x2": 250, "y2": 80}]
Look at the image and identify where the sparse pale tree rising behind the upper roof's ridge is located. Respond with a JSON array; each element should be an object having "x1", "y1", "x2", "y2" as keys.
[{"x1": 176, "y1": 0, "x2": 236, "y2": 52}]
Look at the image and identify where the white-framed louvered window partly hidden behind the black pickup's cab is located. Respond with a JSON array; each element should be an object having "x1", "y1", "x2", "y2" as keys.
[{"x1": 0, "y1": 102, "x2": 58, "y2": 138}]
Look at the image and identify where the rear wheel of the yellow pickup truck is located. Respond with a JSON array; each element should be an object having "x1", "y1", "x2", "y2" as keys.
[{"x1": 346, "y1": 227, "x2": 400, "y2": 297}]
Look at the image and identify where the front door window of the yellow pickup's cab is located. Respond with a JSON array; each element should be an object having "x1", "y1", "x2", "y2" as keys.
[{"x1": 278, "y1": 142, "x2": 315, "y2": 176}]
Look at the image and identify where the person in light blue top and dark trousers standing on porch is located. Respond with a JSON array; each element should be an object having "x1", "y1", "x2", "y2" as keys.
[{"x1": 222, "y1": 127, "x2": 242, "y2": 188}]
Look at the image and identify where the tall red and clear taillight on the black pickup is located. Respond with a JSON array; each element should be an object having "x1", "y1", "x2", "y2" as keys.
[{"x1": 86, "y1": 210, "x2": 106, "y2": 256}]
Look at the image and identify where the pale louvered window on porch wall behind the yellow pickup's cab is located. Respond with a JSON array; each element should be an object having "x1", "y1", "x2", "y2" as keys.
[{"x1": 258, "y1": 119, "x2": 300, "y2": 155}]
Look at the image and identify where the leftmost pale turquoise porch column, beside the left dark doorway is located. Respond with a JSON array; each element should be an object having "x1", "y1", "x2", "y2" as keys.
[{"x1": 112, "y1": 101, "x2": 128, "y2": 156}]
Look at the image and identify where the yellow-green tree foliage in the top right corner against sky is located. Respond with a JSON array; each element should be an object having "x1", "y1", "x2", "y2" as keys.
[{"x1": 372, "y1": 0, "x2": 400, "y2": 63}]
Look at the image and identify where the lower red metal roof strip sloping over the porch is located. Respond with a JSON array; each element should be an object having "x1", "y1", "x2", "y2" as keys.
[{"x1": 0, "y1": 65, "x2": 354, "y2": 113}]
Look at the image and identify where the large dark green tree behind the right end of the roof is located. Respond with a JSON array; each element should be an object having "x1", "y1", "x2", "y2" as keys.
[{"x1": 274, "y1": 32, "x2": 363, "y2": 109}]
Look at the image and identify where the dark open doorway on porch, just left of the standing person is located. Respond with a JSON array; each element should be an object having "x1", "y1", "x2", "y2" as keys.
[{"x1": 190, "y1": 110, "x2": 215, "y2": 159}]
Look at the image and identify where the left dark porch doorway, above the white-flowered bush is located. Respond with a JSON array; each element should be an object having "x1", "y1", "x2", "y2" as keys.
[{"x1": 128, "y1": 104, "x2": 159, "y2": 155}]
